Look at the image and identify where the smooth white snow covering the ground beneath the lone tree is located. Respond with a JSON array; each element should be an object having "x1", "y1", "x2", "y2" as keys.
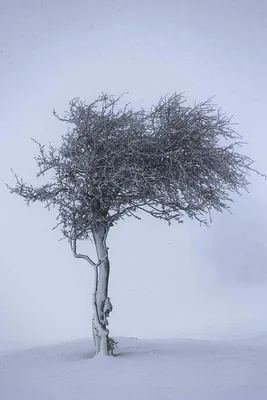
[{"x1": 0, "y1": 336, "x2": 267, "y2": 400}]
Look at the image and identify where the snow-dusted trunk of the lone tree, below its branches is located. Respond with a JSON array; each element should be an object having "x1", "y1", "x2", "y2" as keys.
[{"x1": 92, "y1": 225, "x2": 114, "y2": 355}]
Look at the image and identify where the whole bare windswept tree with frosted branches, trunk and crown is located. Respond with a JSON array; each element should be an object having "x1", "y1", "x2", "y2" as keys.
[{"x1": 8, "y1": 94, "x2": 262, "y2": 355}]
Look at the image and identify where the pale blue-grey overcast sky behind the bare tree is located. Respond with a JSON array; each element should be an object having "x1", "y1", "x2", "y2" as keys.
[{"x1": 0, "y1": 0, "x2": 267, "y2": 350}]
